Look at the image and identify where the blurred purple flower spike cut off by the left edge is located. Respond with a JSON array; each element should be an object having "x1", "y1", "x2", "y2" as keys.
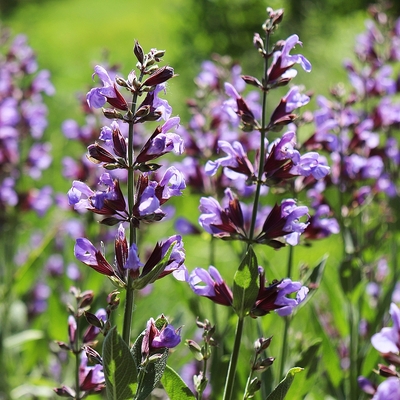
[{"x1": 0, "y1": 29, "x2": 55, "y2": 218}]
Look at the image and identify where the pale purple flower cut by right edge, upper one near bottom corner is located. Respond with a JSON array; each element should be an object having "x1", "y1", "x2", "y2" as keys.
[{"x1": 371, "y1": 303, "x2": 400, "y2": 354}]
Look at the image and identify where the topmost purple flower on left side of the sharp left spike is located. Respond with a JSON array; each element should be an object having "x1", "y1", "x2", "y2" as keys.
[{"x1": 86, "y1": 65, "x2": 128, "y2": 110}]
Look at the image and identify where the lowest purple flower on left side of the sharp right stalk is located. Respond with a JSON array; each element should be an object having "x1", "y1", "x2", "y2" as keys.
[{"x1": 188, "y1": 265, "x2": 233, "y2": 306}]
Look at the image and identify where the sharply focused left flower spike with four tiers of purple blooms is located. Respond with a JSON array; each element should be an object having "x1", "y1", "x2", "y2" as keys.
[{"x1": 68, "y1": 42, "x2": 186, "y2": 288}]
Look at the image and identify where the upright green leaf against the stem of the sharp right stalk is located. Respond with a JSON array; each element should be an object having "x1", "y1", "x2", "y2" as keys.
[{"x1": 233, "y1": 246, "x2": 260, "y2": 318}]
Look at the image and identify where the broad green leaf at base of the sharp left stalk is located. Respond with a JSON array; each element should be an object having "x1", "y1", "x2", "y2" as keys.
[{"x1": 103, "y1": 327, "x2": 137, "y2": 400}]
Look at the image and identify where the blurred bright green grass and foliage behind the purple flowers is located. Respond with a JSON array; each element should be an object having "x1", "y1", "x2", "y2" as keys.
[{"x1": 0, "y1": 0, "x2": 400, "y2": 400}]
